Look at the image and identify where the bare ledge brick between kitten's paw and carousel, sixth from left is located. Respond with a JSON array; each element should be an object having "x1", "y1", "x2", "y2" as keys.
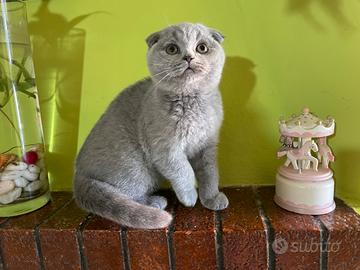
[{"x1": 220, "y1": 187, "x2": 267, "y2": 269}]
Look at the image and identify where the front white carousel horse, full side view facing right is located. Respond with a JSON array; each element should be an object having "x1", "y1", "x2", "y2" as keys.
[{"x1": 278, "y1": 140, "x2": 319, "y2": 171}]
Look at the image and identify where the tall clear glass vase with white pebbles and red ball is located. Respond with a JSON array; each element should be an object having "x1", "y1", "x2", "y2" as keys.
[{"x1": 0, "y1": 0, "x2": 50, "y2": 217}]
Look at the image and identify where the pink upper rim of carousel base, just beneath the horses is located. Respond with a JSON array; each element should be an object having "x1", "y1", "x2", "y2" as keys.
[{"x1": 278, "y1": 165, "x2": 333, "y2": 181}]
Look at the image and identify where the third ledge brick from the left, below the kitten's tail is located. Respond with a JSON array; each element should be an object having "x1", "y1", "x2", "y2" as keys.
[{"x1": 82, "y1": 216, "x2": 124, "y2": 270}]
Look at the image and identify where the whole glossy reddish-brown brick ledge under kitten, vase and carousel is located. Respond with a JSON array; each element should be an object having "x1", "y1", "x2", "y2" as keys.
[{"x1": 0, "y1": 187, "x2": 360, "y2": 270}]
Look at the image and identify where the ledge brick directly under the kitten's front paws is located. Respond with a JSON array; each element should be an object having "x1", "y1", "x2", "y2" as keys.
[{"x1": 173, "y1": 202, "x2": 216, "y2": 270}]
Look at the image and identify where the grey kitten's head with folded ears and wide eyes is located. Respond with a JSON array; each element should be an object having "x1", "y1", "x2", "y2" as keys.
[{"x1": 146, "y1": 23, "x2": 225, "y2": 91}]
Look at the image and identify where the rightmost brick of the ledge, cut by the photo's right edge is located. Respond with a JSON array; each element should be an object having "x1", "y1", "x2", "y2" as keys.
[{"x1": 320, "y1": 196, "x2": 360, "y2": 270}]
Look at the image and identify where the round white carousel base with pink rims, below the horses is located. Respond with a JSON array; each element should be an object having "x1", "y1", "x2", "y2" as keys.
[{"x1": 274, "y1": 168, "x2": 335, "y2": 215}]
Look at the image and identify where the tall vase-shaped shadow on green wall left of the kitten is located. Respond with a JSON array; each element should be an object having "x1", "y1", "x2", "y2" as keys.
[{"x1": 29, "y1": 0, "x2": 91, "y2": 190}]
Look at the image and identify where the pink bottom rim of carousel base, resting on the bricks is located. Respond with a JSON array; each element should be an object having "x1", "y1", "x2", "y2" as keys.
[{"x1": 274, "y1": 195, "x2": 336, "y2": 215}]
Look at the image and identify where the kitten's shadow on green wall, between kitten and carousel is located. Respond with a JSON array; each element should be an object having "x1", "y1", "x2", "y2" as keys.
[{"x1": 219, "y1": 56, "x2": 275, "y2": 184}]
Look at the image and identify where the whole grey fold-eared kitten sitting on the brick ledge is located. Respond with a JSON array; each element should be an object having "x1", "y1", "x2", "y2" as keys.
[{"x1": 74, "y1": 23, "x2": 228, "y2": 229}]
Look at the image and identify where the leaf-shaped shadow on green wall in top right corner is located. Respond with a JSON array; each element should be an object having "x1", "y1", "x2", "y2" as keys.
[{"x1": 286, "y1": 0, "x2": 355, "y2": 31}]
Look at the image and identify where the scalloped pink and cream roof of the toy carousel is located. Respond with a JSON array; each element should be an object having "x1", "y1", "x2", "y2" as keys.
[{"x1": 279, "y1": 108, "x2": 335, "y2": 138}]
